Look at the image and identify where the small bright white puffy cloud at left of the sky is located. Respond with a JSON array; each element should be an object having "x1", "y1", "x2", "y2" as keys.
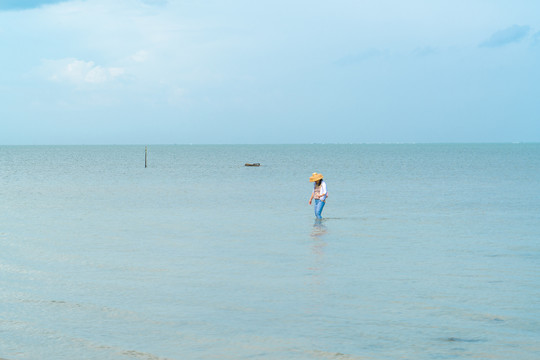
[{"x1": 41, "y1": 58, "x2": 125, "y2": 85}]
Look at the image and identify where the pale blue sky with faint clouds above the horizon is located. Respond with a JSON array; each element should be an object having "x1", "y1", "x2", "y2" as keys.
[{"x1": 0, "y1": 0, "x2": 540, "y2": 145}]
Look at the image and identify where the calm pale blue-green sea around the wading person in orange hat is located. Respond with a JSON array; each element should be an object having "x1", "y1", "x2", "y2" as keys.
[{"x1": 0, "y1": 144, "x2": 540, "y2": 360}]
